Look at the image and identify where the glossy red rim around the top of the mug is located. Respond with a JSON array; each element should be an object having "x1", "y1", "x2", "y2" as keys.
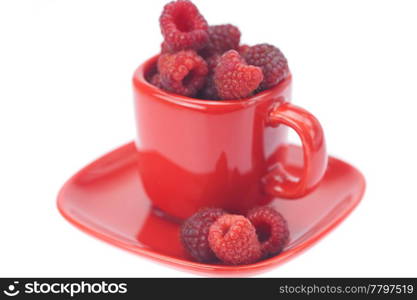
[{"x1": 133, "y1": 54, "x2": 292, "y2": 110}]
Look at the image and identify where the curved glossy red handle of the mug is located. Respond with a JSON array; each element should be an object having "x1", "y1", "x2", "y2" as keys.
[{"x1": 264, "y1": 103, "x2": 327, "y2": 199}]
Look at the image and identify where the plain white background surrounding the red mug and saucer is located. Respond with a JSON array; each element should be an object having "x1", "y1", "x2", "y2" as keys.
[{"x1": 0, "y1": 0, "x2": 417, "y2": 277}]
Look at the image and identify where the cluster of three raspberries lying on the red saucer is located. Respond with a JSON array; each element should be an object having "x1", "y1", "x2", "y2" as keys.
[{"x1": 180, "y1": 206, "x2": 289, "y2": 265}]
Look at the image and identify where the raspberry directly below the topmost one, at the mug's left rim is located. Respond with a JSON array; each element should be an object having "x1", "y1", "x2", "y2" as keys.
[{"x1": 158, "y1": 50, "x2": 208, "y2": 97}]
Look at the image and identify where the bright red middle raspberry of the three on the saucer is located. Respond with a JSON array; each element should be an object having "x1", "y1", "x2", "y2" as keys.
[{"x1": 208, "y1": 214, "x2": 261, "y2": 265}]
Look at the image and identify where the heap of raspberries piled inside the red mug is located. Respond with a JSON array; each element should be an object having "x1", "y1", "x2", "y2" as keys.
[{"x1": 147, "y1": 0, "x2": 289, "y2": 100}]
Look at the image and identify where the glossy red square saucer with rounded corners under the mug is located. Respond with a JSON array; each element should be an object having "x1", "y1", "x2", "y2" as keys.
[{"x1": 58, "y1": 143, "x2": 365, "y2": 276}]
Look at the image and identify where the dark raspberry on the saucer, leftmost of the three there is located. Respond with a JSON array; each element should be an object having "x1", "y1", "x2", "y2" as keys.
[{"x1": 180, "y1": 208, "x2": 225, "y2": 262}]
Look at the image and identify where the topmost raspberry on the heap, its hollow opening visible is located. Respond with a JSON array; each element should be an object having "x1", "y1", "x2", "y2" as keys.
[{"x1": 159, "y1": 0, "x2": 208, "y2": 51}]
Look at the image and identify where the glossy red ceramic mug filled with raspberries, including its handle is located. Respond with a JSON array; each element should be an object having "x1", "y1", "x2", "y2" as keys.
[{"x1": 133, "y1": 57, "x2": 327, "y2": 218}]
